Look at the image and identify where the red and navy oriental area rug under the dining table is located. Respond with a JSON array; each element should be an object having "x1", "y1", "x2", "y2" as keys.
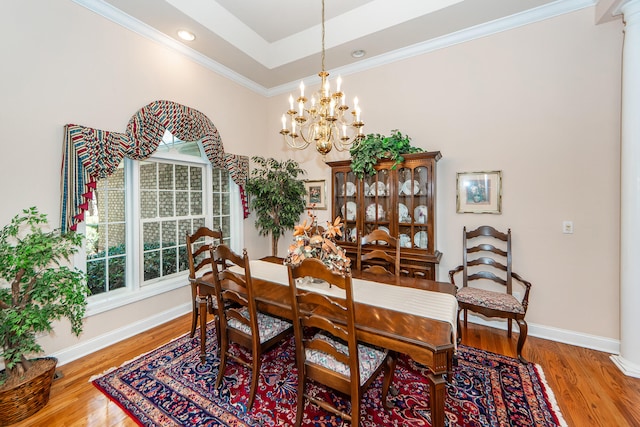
[{"x1": 92, "y1": 324, "x2": 566, "y2": 427}]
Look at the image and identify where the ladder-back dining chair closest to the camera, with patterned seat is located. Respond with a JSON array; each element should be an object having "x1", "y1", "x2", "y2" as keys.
[{"x1": 288, "y1": 258, "x2": 396, "y2": 427}]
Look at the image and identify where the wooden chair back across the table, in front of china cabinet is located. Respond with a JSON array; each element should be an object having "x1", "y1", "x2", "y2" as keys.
[{"x1": 356, "y1": 229, "x2": 400, "y2": 276}]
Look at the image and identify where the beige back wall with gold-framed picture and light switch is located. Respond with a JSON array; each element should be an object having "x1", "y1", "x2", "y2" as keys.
[{"x1": 269, "y1": 8, "x2": 622, "y2": 340}]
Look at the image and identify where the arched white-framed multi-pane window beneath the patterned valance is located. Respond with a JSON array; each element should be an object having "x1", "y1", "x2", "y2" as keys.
[{"x1": 85, "y1": 133, "x2": 242, "y2": 311}]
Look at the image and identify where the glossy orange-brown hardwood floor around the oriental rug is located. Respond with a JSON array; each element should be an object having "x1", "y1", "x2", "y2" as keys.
[{"x1": 14, "y1": 315, "x2": 640, "y2": 427}]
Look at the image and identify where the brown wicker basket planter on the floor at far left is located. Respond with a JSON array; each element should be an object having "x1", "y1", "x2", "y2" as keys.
[{"x1": 0, "y1": 357, "x2": 58, "y2": 426}]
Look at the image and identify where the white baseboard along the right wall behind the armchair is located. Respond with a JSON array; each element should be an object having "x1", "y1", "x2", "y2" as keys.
[{"x1": 461, "y1": 313, "x2": 620, "y2": 354}]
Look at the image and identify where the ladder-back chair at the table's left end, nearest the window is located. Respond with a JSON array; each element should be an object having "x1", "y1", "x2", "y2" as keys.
[{"x1": 186, "y1": 227, "x2": 223, "y2": 362}]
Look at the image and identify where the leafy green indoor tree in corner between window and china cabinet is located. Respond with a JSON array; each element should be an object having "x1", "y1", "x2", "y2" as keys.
[{"x1": 246, "y1": 156, "x2": 307, "y2": 256}]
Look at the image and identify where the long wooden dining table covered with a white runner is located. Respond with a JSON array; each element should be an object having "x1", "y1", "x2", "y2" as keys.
[{"x1": 212, "y1": 257, "x2": 458, "y2": 427}]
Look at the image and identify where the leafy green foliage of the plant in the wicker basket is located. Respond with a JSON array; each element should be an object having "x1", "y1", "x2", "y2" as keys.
[{"x1": 0, "y1": 207, "x2": 87, "y2": 378}]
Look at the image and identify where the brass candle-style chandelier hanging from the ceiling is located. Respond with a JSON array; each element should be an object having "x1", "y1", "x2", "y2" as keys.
[{"x1": 280, "y1": 0, "x2": 364, "y2": 155}]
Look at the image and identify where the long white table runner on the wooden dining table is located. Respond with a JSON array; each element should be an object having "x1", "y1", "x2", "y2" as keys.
[{"x1": 231, "y1": 260, "x2": 458, "y2": 343}]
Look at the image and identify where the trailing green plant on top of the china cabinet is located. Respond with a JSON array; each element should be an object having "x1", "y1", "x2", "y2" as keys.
[{"x1": 349, "y1": 129, "x2": 424, "y2": 179}]
